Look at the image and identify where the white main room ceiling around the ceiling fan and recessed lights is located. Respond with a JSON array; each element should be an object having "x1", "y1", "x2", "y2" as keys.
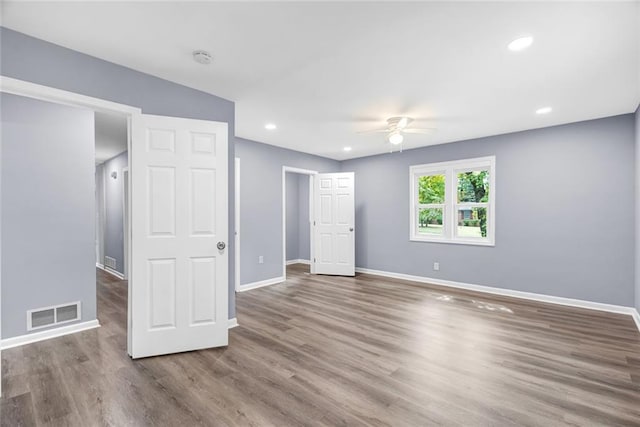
[{"x1": 3, "y1": 1, "x2": 640, "y2": 159}]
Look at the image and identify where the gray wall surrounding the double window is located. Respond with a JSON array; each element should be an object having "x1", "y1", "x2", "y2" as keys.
[{"x1": 341, "y1": 114, "x2": 635, "y2": 306}]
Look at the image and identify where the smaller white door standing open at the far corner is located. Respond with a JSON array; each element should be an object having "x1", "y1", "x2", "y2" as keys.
[{"x1": 312, "y1": 172, "x2": 355, "y2": 276}]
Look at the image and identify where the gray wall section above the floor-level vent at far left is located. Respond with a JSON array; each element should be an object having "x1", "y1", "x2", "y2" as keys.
[{"x1": 0, "y1": 94, "x2": 96, "y2": 338}]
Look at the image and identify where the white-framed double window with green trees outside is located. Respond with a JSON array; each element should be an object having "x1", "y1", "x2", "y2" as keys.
[{"x1": 410, "y1": 157, "x2": 496, "y2": 246}]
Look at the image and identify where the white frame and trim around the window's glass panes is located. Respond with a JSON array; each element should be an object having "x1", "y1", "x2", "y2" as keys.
[{"x1": 409, "y1": 156, "x2": 496, "y2": 246}]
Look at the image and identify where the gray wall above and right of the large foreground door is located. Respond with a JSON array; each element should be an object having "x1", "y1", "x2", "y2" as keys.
[{"x1": 0, "y1": 27, "x2": 235, "y2": 317}]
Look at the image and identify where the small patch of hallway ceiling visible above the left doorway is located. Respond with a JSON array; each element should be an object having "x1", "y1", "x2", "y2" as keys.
[{"x1": 95, "y1": 112, "x2": 127, "y2": 165}]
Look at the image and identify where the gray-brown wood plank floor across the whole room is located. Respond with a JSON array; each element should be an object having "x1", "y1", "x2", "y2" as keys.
[{"x1": 0, "y1": 265, "x2": 640, "y2": 426}]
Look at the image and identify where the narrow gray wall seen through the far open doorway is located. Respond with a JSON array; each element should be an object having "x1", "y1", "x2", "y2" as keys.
[{"x1": 286, "y1": 172, "x2": 310, "y2": 261}]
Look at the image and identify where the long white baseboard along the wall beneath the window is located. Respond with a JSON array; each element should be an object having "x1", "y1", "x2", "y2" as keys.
[{"x1": 356, "y1": 267, "x2": 640, "y2": 331}]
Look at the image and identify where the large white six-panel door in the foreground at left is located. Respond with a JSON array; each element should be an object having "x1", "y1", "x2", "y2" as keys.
[{"x1": 129, "y1": 115, "x2": 228, "y2": 358}]
